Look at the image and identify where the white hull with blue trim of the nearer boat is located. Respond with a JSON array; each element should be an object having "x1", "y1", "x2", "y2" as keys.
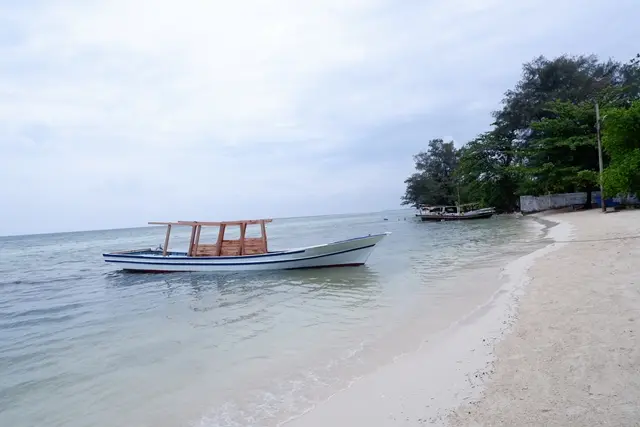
[{"x1": 103, "y1": 233, "x2": 389, "y2": 272}]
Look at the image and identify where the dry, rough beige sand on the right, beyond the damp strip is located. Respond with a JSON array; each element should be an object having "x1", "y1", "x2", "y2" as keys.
[{"x1": 449, "y1": 211, "x2": 640, "y2": 426}]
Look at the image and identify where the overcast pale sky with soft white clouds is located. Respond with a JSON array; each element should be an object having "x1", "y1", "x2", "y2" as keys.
[{"x1": 0, "y1": 0, "x2": 640, "y2": 235}]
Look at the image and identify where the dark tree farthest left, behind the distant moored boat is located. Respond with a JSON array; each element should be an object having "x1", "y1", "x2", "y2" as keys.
[{"x1": 402, "y1": 139, "x2": 457, "y2": 207}]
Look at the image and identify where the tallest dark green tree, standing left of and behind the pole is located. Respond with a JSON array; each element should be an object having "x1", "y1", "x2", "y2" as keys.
[{"x1": 494, "y1": 55, "x2": 640, "y2": 205}]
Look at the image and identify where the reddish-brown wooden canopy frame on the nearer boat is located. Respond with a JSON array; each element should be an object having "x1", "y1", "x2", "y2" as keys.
[{"x1": 149, "y1": 219, "x2": 273, "y2": 257}]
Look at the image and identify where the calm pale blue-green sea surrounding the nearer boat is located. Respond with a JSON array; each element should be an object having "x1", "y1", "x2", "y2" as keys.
[{"x1": 0, "y1": 211, "x2": 544, "y2": 427}]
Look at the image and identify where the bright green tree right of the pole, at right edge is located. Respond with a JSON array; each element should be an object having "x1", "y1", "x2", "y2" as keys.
[{"x1": 602, "y1": 101, "x2": 640, "y2": 195}]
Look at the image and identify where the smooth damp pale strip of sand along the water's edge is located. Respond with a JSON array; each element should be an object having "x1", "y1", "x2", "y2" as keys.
[{"x1": 278, "y1": 213, "x2": 573, "y2": 427}]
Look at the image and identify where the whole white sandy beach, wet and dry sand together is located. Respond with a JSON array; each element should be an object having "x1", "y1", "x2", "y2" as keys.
[{"x1": 286, "y1": 210, "x2": 640, "y2": 427}]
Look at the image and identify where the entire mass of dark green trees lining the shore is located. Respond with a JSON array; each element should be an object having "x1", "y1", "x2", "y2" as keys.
[{"x1": 402, "y1": 55, "x2": 640, "y2": 211}]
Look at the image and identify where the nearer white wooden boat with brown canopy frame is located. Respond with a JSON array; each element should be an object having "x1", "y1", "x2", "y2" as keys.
[{"x1": 103, "y1": 219, "x2": 390, "y2": 272}]
